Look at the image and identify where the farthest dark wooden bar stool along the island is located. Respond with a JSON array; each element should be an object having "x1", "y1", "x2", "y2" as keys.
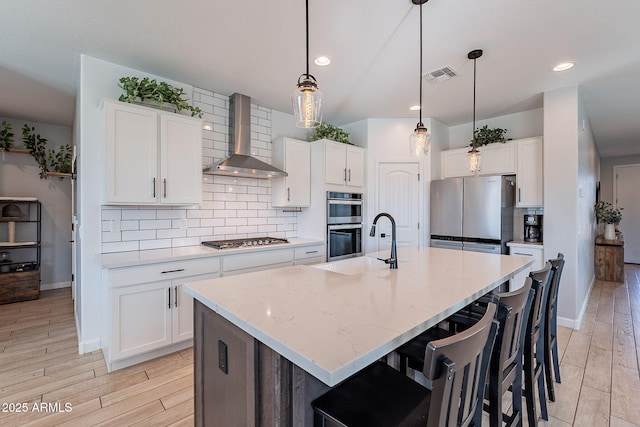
[{"x1": 544, "y1": 253, "x2": 564, "y2": 402}]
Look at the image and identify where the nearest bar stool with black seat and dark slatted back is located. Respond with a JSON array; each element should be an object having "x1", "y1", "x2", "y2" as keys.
[{"x1": 311, "y1": 304, "x2": 498, "y2": 427}]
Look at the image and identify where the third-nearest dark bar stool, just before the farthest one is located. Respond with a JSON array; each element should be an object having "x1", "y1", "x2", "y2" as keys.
[{"x1": 522, "y1": 262, "x2": 552, "y2": 426}]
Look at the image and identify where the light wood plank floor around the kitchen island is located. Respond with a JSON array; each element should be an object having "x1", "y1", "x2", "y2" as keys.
[{"x1": 0, "y1": 265, "x2": 640, "y2": 427}]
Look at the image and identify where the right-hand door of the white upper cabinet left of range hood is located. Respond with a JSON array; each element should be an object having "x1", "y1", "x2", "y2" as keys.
[{"x1": 158, "y1": 113, "x2": 202, "y2": 204}]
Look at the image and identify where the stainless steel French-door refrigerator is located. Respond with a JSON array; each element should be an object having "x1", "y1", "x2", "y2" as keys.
[{"x1": 430, "y1": 176, "x2": 515, "y2": 254}]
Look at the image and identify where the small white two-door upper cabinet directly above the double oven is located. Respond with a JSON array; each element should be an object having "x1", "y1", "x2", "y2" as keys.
[{"x1": 314, "y1": 139, "x2": 364, "y2": 187}]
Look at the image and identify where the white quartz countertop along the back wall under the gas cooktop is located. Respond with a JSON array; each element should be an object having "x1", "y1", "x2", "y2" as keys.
[{"x1": 96, "y1": 238, "x2": 324, "y2": 268}]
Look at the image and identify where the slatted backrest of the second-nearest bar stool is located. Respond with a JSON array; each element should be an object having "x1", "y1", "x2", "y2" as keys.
[{"x1": 491, "y1": 277, "x2": 535, "y2": 371}]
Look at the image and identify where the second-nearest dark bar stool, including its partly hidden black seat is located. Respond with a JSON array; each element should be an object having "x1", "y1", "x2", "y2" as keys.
[{"x1": 398, "y1": 277, "x2": 534, "y2": 426}]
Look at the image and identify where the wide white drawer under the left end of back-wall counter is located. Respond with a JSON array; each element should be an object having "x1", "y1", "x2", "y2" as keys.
[{"x1": 110, "y1": 257, "x2": 220, "y2": 287}]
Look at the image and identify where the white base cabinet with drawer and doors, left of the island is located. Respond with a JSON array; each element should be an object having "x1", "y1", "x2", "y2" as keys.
[{"x1": 103, "y1": 257, "x2": 220, "y2": 369}]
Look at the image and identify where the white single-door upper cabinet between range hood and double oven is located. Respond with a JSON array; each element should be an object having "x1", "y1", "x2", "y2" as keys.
[{"x1": 271, "y1": 138, "x2": 311, "y2": 208}]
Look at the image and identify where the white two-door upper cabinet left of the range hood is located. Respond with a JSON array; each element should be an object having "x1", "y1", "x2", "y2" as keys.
[{"x1": 104, "y1": 100, "x2": 202, "y2": 205}]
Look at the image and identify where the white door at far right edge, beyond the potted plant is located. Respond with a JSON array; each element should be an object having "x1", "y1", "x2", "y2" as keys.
[{"x1": 613, "y1": 165, "x2": 640, "y2": 264}]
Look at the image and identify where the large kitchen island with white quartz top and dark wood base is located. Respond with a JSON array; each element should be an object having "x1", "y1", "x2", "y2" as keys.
[{"x1": 185, "y1": 247, "x2": 531, "y2": 426}]
